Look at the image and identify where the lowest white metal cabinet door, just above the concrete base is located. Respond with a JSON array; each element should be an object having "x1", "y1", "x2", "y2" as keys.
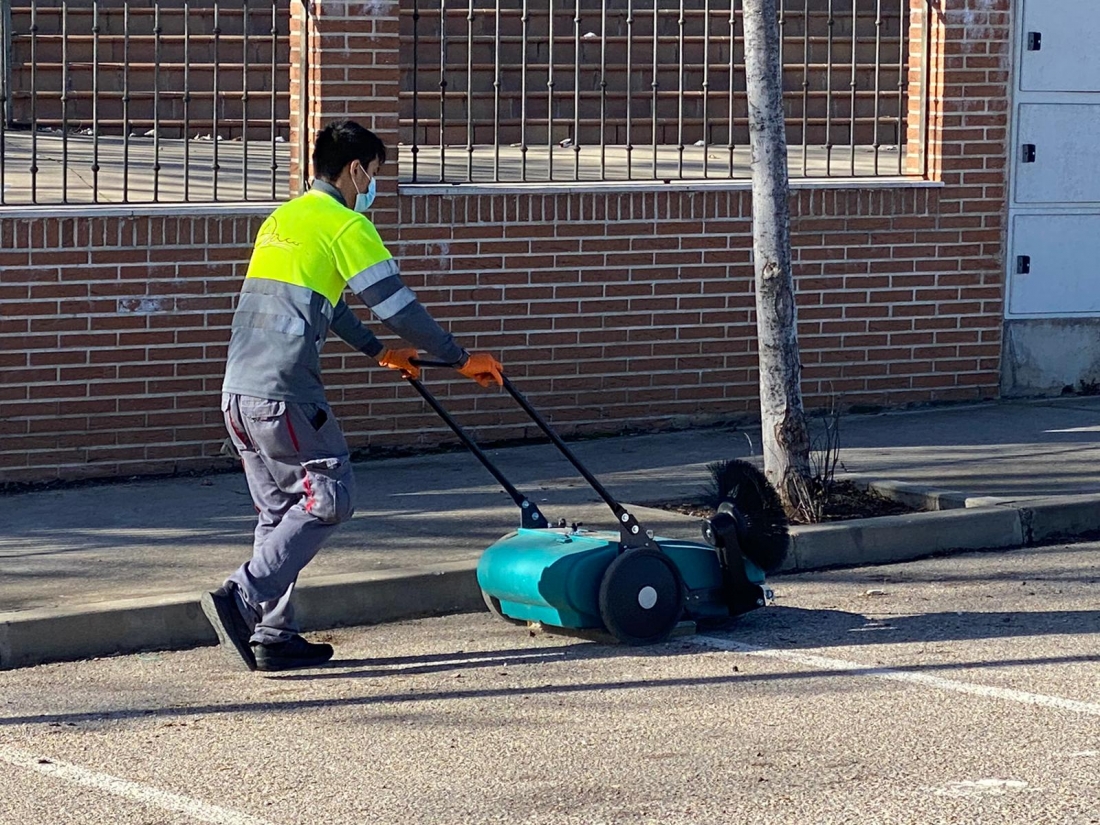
[{"x1": 1008, "y1": 215, "x2": 1100, "y2": 317}]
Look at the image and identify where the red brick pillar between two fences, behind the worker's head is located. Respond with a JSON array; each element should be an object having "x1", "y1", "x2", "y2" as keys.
[{"x1": 290, "y1": 0, "x2": 400, "y2": 214}]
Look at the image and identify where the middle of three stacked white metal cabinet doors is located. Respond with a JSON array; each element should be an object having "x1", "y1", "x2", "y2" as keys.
[{"x1": 1014, "y1": 103, "x2": 1100, "y2": 204}]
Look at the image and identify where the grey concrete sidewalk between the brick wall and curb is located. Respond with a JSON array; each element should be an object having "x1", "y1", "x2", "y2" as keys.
[{"x1": 0, "y1": 397, "x2": 1100, "y2": 667}]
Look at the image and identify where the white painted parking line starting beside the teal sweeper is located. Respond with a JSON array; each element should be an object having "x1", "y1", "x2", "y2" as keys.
[{"x1": 695, "y1": 636, "x2": 1100, "y2": 716}]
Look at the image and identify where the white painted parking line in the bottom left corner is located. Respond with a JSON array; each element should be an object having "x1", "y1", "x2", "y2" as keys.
[{"x1": 0, "y1": 745, "x2": 271, "y2": 825}]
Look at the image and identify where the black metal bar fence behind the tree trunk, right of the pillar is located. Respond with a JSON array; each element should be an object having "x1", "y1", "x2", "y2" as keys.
[{"x1": 402, "y1": 0, "x2": 910, "y2": 184}]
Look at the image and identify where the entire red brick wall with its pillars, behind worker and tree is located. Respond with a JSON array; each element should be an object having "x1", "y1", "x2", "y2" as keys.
[{"x1": 0, "y1": 0, "x2": 1009, "y2": 482}]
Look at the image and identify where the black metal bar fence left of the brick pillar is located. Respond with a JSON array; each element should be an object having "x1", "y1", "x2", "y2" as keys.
[{"x1": 0, "y1": 0, "x2": 289, "y2": 206}]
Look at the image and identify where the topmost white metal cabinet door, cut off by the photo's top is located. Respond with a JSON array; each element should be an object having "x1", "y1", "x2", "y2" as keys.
[{"x1": 1020, "y1": 0, "x2": 1100, "y2": 91}]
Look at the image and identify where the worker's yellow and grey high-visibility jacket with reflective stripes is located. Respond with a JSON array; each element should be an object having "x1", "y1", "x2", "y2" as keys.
[{"x1": 222, "y1": 180, "x2": 466, "y2": 404}]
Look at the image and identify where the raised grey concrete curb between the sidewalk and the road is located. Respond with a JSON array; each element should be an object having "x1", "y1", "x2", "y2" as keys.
[{"x1": 0, "y1": 491, "x2": 1100, "y2": 669}]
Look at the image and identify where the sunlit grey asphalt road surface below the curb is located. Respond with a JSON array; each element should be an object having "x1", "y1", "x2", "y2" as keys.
[{"x1": 0, "y1": 543, "x2": 1100, "y2": 825}]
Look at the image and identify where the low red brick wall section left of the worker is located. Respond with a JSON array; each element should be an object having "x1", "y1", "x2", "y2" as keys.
[{"x1": 0, "y1": 212, "x2": 259, "y2": 482}]
